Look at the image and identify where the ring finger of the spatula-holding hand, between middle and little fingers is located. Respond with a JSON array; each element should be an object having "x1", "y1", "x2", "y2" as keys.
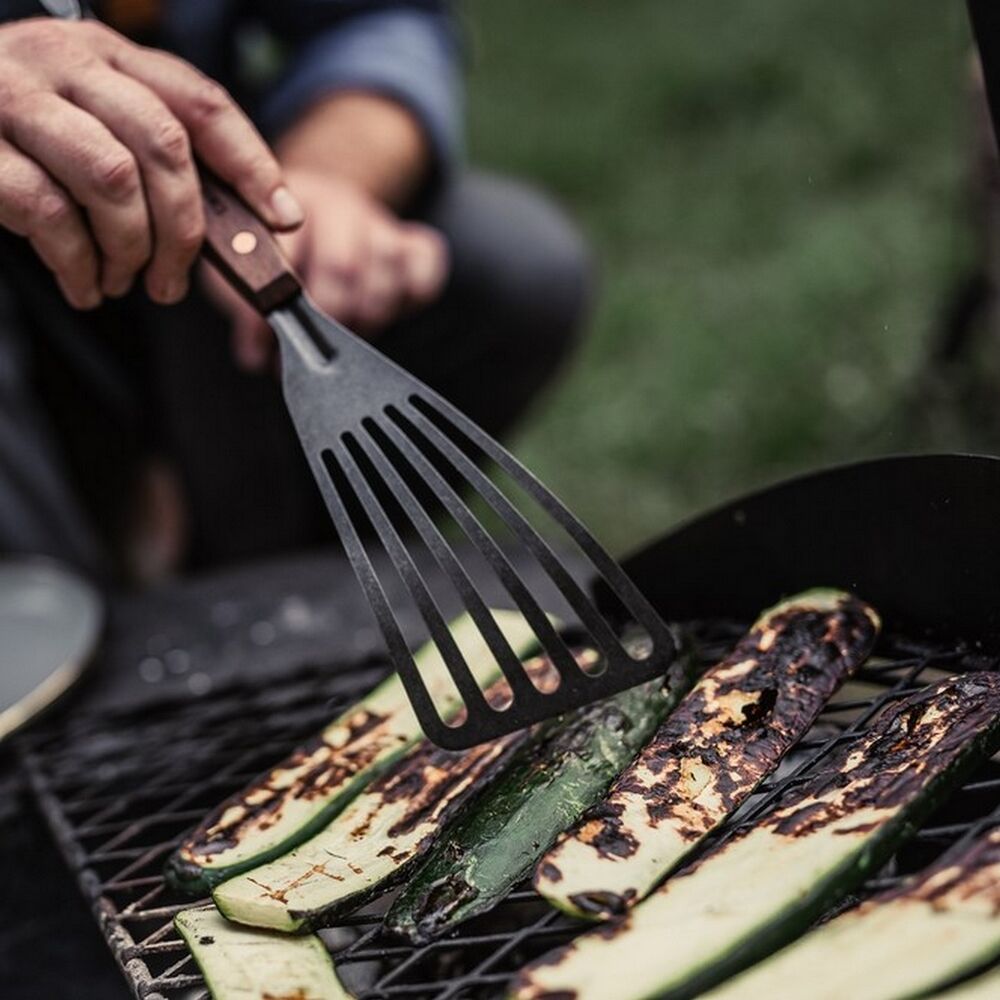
[{"x1": 4, "y1": 93, "x2": 151, "y2": 296}]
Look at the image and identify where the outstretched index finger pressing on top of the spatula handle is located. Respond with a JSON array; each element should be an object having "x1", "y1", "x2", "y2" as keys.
[{"x1": 111, "y1": 46, "x2": 303, "y2": 229}]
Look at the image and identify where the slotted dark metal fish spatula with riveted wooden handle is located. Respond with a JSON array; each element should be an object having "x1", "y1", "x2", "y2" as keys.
[{"x1": 203, "y1": 177, "x2": 675, "y2": 749}]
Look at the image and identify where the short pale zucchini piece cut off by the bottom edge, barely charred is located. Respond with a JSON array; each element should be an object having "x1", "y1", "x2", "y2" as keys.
[{"x1": 174, "y1": 906, "x2": 351, "y2": 1000}]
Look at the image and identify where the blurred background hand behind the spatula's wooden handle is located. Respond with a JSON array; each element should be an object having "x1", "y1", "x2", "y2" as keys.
[{"x1": 205, "y1": 169, "x2": 448, "y2": 370}]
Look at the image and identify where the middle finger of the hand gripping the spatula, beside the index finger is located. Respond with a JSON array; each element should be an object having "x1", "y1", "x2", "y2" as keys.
[{"x1": 63, "y1": 68, "x2": 205, "y2": 303}]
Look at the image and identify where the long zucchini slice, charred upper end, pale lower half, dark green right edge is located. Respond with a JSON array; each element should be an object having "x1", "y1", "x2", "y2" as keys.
[{"x1": 513, "y1": 673, "x2": 1000, "y2": 1000}]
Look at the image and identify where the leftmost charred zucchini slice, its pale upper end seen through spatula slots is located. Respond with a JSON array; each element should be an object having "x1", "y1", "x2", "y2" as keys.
[{"x1": 167, "y1": 611, "x2": 537, "y2": 892}]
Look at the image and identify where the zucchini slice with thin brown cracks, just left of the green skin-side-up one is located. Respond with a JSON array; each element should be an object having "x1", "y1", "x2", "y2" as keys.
[{"x1": 213, "y1": 650, "x2": 568, "y2": 931}]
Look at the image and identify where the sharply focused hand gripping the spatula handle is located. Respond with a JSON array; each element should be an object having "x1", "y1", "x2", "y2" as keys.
[{"x1": 0, "y1": 19, "x2": 302, "y2": 309}]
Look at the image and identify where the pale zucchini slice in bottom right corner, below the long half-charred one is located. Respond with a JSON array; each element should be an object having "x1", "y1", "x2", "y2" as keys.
[{"x1": 706, "y1": 830, "x2": 1000, "y2": 1000}]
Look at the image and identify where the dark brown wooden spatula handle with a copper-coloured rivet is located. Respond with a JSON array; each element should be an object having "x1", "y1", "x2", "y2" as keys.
[{"x1": 201, "y1": 171, "x2": 302, "y2": 314}]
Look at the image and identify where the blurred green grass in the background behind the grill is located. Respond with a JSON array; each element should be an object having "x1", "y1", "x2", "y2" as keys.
[{"x1": 467, "y1": 0, "x2": 973, "y2": 551}]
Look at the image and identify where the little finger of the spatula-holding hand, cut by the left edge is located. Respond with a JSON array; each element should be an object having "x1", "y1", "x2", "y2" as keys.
[{"x1": 0, "y1": 142, "x2": 101, "y2": 309}]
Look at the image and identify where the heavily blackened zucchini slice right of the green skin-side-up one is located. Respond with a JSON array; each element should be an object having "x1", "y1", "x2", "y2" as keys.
[{"x1": 534, "y1": 590, "x2": 879, "y2": 919}]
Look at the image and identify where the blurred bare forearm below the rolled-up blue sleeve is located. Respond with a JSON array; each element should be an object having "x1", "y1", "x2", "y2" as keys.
[{"x1": 276, "y1": 91, "x2": 432, "y2": 208}]
